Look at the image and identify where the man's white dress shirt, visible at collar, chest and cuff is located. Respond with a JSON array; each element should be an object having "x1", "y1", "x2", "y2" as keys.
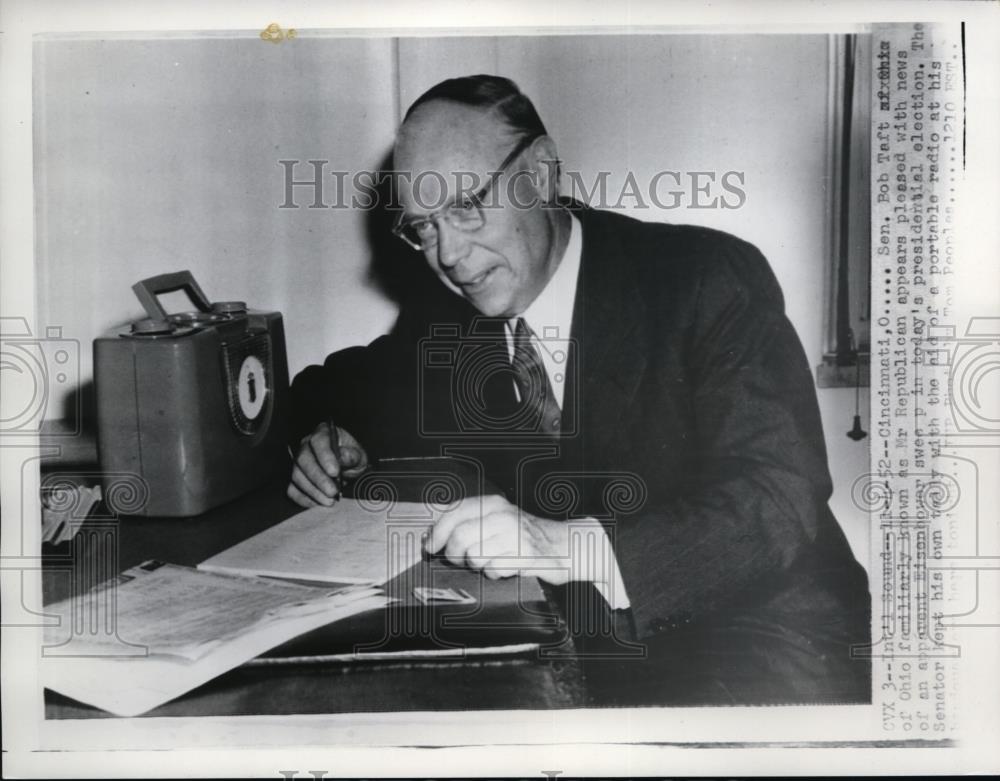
[{"x1": 504, "y1": 214, "x2": 629, "y2": 610}]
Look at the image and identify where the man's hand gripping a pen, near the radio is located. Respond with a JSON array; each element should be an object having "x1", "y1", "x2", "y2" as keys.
[{"x1": 288, "y1": 423, "x2": 368, "y2": 507}]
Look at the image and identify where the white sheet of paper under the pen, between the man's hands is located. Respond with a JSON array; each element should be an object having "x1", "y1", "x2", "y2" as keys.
[{"x1": 198, "y1": 499, "x2": 440, "y2": 585}]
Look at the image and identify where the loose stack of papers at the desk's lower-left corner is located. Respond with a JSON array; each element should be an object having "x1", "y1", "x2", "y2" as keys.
[{"x1": 41, "y1": 562, "x2": 390, "y2": 716}]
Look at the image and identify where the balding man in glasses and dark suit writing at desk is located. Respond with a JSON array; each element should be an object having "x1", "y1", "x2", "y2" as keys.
[{"x1": 288, "y1": 76, "x2": 870, "y2": 704}]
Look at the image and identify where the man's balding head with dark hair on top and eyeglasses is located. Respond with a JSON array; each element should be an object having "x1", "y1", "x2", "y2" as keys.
[{"x1": 393, "y1": 76, "x2": 569, "y2": 317}]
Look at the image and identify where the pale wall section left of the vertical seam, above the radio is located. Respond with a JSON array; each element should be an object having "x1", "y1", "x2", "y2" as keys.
[{"x1": 35, "y1": 38, "x2": 396, "y2": 386}]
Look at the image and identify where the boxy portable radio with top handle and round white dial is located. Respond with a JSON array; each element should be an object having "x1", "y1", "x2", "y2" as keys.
[{"x1": 94, "y1": 271, "x2": 288, "y2": 516}]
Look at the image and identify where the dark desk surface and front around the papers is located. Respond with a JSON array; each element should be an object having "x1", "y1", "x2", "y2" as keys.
[{"x1": 43, "y1": 466, "x2": 586, "y2": 719}]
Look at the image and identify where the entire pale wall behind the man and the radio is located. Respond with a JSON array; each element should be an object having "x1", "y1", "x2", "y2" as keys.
[{"x1": 35, "y1": 35, "x2": 868, "y2": 561}]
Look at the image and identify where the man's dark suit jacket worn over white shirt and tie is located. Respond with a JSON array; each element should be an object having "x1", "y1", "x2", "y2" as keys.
[{"x1": 293, "y1": 201, "x2": 869, "y2": 639}]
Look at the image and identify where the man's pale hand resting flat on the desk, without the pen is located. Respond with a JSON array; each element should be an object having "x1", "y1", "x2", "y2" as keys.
[{"x1": 424, "y1": 496, "x2": 571, "y2": 585}]
